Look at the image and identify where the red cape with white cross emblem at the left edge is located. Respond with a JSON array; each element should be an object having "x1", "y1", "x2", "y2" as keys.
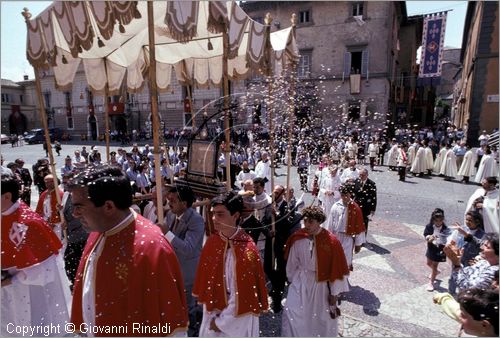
[{"x1": 1, "y1": 200, "x2": 62, "y2": 270}]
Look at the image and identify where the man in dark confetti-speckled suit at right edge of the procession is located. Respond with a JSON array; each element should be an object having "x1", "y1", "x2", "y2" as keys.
[{"x1": 354, "y1": 168, "x2": 377, "y2": 235}]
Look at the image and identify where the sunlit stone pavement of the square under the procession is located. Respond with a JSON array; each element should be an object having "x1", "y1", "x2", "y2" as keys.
[{"x1": 1, "y1": 144, "x2": 478, "y2": 337}]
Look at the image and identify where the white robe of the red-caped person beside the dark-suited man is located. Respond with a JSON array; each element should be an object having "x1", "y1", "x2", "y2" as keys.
[{"x1": 323, "y1": 200, "x2": 365, "y2": 266}]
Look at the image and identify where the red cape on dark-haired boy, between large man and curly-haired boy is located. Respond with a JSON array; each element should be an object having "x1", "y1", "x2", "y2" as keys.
[{"x1": 193, "y1": 229, "x2": 269, "y2": 315}]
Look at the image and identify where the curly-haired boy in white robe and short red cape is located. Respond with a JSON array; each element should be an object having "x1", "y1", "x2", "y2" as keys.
[{"x1": 281, "y1": 206, "x2": 349, "y2": 337}]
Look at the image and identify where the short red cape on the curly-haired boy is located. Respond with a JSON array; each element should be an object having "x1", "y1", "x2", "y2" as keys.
[{"x1": 285, "y1": 229, "x2": 349, "y2": 282}]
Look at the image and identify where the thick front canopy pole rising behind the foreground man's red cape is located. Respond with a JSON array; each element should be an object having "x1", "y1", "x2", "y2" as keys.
[{"x1": 148, "y1": 1, "x2": 168, "y2": 224}]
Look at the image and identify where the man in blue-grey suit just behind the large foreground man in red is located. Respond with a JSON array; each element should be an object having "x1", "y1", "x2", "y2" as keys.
[{"x1": 160, "y1": 186, "x2": 205, "y2": 336}]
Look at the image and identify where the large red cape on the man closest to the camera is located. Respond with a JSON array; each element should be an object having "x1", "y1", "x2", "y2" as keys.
[{"x1": 71, "y1": 214, "x2": 188, "y2": 336}]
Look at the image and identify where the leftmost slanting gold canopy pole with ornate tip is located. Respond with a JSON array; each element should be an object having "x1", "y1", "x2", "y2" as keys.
[{"x1": 21, "y1": 7, "x2": 66, "y2": 237}]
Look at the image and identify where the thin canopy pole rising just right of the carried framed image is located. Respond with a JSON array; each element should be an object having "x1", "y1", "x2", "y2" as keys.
[{"x1": 222, "y1": 26, "x2": 232, "y2": 191}]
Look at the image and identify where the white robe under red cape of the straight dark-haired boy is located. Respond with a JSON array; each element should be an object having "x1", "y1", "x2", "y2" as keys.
[{"x1": 200, "y1": 247, "x2": 259, "y2": 337}]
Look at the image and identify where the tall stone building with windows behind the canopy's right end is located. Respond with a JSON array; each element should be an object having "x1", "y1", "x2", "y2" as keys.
[{"x1": 242, "y1": 1, "x2": 421, "y2": 133}]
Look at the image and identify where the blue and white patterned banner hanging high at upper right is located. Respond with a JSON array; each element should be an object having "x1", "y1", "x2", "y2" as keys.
[{"x1": 418, "y1": 12, "x2": 447, "y2": 78}]
